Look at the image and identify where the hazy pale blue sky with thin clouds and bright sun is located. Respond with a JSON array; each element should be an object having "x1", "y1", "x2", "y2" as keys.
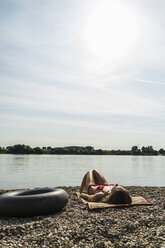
[{"x1": 0, "y1": 0, "x2": 165, "y2": 150}]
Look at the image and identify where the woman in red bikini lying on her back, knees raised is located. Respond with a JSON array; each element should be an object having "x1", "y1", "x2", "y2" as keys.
[{"x1": 80, "y1": 170, "x2": 132, "y2": 204}]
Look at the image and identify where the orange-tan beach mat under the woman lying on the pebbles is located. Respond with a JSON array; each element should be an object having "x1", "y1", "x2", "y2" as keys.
[{"x1": 76, "y1": 192, "x2": 152, "y2": 209}]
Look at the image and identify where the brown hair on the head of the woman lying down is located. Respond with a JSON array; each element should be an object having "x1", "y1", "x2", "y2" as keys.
[{"x1": 104, "y1": 187, "x2": 132, "y2": 204}]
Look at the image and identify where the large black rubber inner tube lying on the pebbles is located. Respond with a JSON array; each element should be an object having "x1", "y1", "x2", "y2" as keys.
[{"x1": 0, "y1": 188, "x2": 68, "y2": 217}]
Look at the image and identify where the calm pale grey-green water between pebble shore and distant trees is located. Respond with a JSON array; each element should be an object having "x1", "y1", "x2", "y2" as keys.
[{"x1": 0, "y1": 154, "x2": 165, "y2": 189}]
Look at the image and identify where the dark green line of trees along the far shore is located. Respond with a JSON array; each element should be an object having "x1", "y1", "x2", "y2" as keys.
[{"x1": 0, "y1": 144, "x2": 165, "y2": 156}]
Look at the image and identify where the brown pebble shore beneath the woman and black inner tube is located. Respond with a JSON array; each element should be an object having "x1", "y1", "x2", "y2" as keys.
[{"x1": 0, "y1": 186, "x2": 165, "y2": 248}]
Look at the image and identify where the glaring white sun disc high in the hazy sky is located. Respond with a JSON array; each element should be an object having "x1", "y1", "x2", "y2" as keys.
[{"x1": 84, "y1": 1, "x2": 139, "y2": 61}]
